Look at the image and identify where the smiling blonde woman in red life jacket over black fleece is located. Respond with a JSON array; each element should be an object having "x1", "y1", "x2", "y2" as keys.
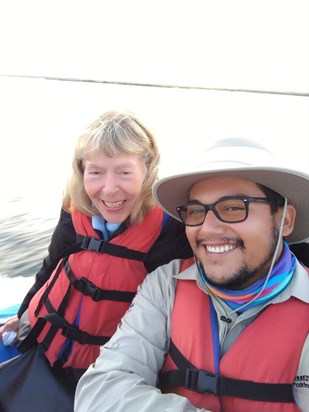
[{"x1": 2, "y1": 112, "x2": 191, "y2": 370}]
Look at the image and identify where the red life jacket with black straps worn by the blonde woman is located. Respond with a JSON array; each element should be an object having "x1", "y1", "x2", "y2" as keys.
[{"x1": 25, "y1": 207, "x2": 163, "y2": 368}]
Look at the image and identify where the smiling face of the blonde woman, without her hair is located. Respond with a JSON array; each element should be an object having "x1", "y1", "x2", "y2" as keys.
[{"x1": 84, "y1": 151, "x2": 147, "y2": 223}]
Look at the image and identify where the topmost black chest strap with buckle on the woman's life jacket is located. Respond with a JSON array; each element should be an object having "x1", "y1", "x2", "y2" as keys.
[{"x1": 76, "y1": 234, "x2": 147, "y2": 262}]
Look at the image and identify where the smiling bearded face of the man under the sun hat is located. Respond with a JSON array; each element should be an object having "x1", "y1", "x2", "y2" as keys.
[{"x1": 186, "y1": 177, "x2": 282, "y2": 289}]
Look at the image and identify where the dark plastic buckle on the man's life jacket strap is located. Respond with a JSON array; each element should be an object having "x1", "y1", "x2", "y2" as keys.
[{"x1": 185, "y1": 368, "x2": 220, "y2": 396}]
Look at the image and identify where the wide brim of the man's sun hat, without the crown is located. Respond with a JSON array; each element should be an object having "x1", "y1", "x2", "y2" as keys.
[{"x1": 153, "y1": 167, "x2": 309, "y2": 243}]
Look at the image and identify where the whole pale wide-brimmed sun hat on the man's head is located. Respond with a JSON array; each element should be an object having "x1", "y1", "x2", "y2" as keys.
[{"x1": 153, "y1": 138, "x2": 309, "y2": 243}]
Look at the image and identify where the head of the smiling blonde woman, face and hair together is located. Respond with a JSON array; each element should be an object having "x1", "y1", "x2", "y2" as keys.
[{"x1": 64, "y1": 112, "x2": 160, "y2": 224}]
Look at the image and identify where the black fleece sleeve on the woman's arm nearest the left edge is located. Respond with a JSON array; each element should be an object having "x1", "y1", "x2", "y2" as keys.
[{"x1": 17, "y1": 209, "x2": 76, "y2": 318}]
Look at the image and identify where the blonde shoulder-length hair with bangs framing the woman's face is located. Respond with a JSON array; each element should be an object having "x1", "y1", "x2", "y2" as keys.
[{"x1": 63, "y1": 111, "x2": 160, "y2": 224}]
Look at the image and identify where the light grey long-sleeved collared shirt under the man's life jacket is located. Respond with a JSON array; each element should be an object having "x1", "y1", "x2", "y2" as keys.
[{"x1": 75, "y1": 260, "x2": 309, "y2": 412}]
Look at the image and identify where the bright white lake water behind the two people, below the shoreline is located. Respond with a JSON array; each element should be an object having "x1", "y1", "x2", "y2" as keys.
[{"x1": 0, "y1": 78, "x2": 309, "y2": 308}]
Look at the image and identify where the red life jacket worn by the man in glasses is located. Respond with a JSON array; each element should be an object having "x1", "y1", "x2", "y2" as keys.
[{"x1": 160, "y1": 260, "x2": 309, "y2": 412}]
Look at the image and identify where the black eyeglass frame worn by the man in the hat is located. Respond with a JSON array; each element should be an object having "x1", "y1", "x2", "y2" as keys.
[{"x1": 176, "y1": 196, "x2": 284, "y2": 227}]
